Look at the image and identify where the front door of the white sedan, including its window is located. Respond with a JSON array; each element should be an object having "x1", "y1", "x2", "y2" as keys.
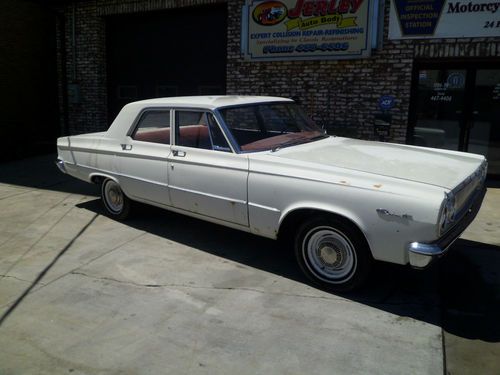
[{"x1": 168, "y1": 110, "x2": 248, "y2": 226}]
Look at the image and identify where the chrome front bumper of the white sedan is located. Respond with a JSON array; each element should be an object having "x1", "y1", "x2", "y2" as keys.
[{"x1": 407, "y1": 187, "x2": 486, "y2": 268}]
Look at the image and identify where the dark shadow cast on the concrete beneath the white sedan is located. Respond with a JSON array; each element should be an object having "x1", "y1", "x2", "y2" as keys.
[{"x1": 78, "y1": 199, "x2": 500, "y2": 342}]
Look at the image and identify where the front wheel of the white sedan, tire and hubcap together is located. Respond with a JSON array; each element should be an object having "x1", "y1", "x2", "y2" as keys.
[{"x1": 295, "y1": 216, "x2": 373, "y2": 292}]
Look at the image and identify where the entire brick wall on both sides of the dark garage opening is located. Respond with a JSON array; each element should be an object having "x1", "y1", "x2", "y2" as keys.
[{"x1": 63, "y1": 0, "x2": 500, "y2": 143}]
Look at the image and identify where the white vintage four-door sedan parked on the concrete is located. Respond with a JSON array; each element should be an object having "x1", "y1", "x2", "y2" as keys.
[{"x1": 57, "y1": 96, "x2": 487, "y2": 291}]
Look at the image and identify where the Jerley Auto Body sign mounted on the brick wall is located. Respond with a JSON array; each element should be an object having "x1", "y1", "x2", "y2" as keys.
[{"x1": 242, "y1": 0, "x2": 372, "y2": 60}]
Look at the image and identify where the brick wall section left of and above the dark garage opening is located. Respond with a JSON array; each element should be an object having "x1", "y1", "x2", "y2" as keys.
[{"x1": 58, "y1": 0, "x2": 226, "y2": 134}]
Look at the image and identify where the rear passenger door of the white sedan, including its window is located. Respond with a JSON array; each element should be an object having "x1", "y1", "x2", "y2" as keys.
[{"x1": 117, "y1": 109, "x2": 171, "y2": 205}]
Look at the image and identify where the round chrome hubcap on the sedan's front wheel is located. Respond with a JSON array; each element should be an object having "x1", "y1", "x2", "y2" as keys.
[{"x1": 302, "y1": 227, "x2": 357, "y2": 283}]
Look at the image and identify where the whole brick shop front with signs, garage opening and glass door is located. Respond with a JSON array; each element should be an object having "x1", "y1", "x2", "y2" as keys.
[{"x1": 54, "y1": 0, "x2": 500, "y2": 175}]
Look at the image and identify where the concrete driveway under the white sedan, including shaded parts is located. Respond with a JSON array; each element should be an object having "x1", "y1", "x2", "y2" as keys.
[{"x1": 0, "y1": 156, "x2": 500, "y2": 375}]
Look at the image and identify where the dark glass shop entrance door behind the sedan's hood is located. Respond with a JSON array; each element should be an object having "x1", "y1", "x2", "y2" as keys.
[{"x1": 408, "y1": 64, "x2": 500, "y2": 176}]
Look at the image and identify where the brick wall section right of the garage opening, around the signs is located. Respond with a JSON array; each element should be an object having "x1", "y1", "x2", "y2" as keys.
[{"x1": 227, "y1": 0, "x2": 500, "y2": 143}]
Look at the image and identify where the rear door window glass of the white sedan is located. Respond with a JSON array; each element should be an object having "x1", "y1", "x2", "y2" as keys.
[{"x1": 132, "y1": 110, "x2": 170, "y2": 145}]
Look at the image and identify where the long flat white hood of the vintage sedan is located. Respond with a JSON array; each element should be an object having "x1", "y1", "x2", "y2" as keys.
[{"x1": 271, "y1": 137, "x2": 484, "y2": 189}]
